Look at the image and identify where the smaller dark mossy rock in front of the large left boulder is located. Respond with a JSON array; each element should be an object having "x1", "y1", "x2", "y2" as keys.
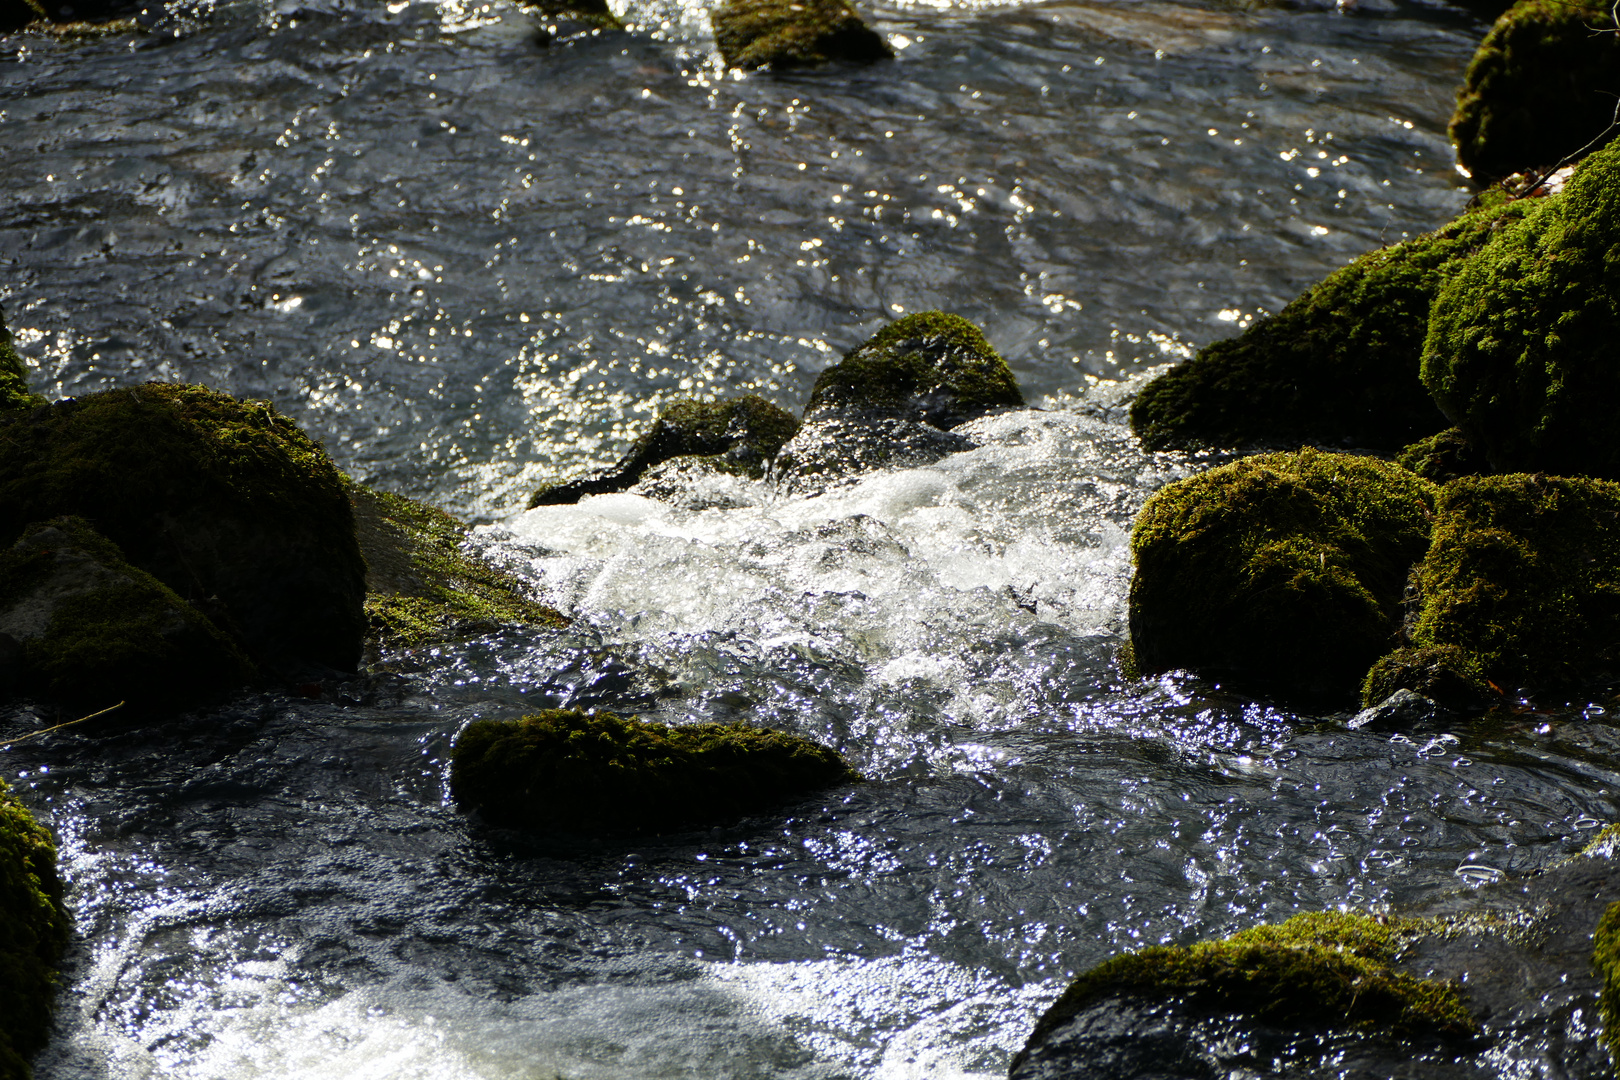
[{"x1": 0, "y1": 518, "x2": 254, "y2": 709}]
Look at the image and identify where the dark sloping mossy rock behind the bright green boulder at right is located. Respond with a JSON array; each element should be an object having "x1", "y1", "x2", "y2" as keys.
[{"x1": 1131, "y1": 199, "x2": 1524, "y2": 450}]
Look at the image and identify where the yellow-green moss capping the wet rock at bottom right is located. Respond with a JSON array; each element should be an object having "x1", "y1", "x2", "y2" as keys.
[{"x1": 1014, "y1": 912, "x2": 1476, "y2": 1069}]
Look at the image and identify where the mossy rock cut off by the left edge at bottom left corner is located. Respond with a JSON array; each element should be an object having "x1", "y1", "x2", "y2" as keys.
[{"x1": 0, "y1": 782, "x2": 71, "y2": 1080}]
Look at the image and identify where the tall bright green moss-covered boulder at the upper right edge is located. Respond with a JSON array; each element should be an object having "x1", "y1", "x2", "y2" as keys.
[{"x1": 1422, "y1": 132, "x2": 1620, "y2": 478}]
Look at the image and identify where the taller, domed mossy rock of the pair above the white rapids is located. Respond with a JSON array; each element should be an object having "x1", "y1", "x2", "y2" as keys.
[{"x1": 805, "y1": 311, "x2": 1024, "y2": 427}]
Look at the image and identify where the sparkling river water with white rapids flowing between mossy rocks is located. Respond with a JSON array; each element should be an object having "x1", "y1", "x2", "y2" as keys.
[{"x1": 0, "y1": 0, "x2": 1620, "y2": 1080}]
